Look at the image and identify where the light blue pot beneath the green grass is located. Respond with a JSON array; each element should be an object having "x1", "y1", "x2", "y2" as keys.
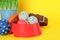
[{"x1": 0, "y1": 10, "x2": 17, "y2": 20}]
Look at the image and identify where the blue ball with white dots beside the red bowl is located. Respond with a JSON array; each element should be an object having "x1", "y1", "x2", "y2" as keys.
[{"x1": 0, "y1": 19, "x2": 10, "y2": 35}]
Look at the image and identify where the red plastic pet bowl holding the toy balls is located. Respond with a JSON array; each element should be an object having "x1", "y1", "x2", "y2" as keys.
[{"x1": 12, "y1": 23, "x2": 41, "y2": 37}]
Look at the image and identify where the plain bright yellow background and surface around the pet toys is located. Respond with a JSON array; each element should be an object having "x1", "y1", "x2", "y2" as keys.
[{"x1": 0, "y1": 0, "x2": 60, "y2": 40}]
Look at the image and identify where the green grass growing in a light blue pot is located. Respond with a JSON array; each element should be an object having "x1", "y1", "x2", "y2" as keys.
[{"x1": 0, "y1": 0, "x2": 18, "y2": 20}]
